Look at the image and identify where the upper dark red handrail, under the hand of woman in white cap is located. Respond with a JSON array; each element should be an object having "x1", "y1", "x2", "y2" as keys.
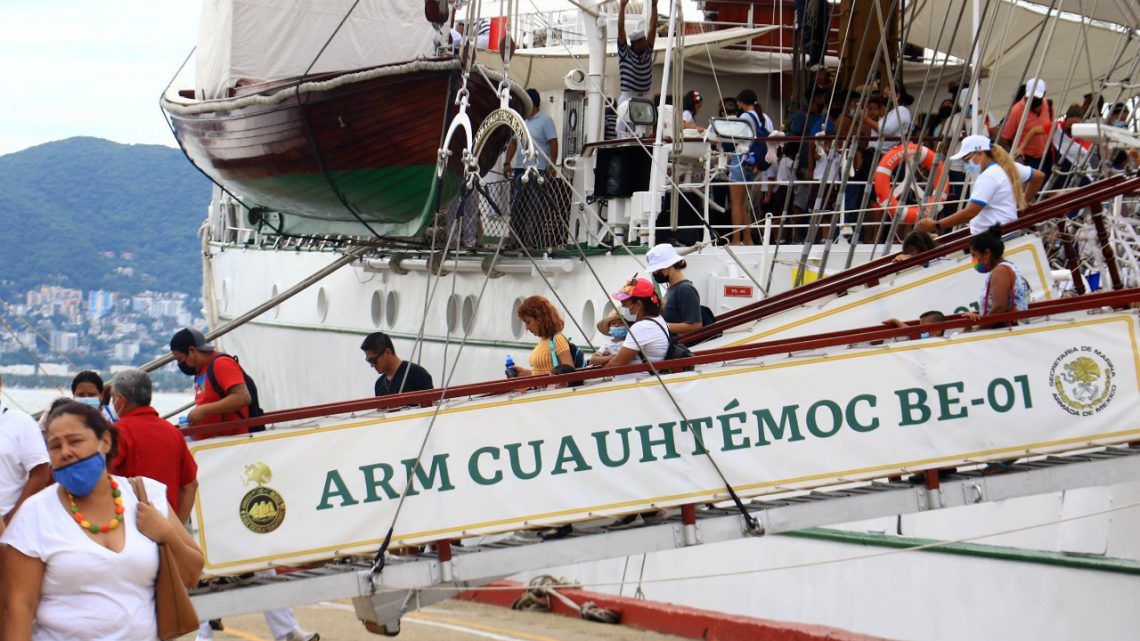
[{"x1": 678, "y1": 176, "x2": 1140, "y2": 344}]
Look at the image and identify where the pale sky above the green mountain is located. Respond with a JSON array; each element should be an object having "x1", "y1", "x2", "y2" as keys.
[{"x1": 0, "y1": 0, "x2": 201, "y2": 154}]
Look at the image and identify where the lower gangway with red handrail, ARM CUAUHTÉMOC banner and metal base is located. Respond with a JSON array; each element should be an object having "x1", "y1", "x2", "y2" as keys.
[{"x1": 187, "y1": 290, "x2": 1140, "y2": 634}]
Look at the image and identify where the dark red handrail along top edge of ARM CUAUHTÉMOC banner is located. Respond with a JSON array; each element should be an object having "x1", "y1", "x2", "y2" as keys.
[{"x1": 182, "y1": 287, "x2": 1140, "y2": 437}]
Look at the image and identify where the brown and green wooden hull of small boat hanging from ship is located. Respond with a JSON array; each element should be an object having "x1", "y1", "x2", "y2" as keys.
[{"x1": 163, "y1": 64, "x2": 518, "y2": 236}]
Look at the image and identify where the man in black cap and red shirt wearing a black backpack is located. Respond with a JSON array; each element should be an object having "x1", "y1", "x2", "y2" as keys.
[{"x1": 170, "y1": 327, "x2": 253, "y2": 436}]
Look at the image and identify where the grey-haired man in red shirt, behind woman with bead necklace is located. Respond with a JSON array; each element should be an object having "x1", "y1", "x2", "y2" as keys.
[{"x1": 111, "y1": 370, "x2": 198, "y2": 521}]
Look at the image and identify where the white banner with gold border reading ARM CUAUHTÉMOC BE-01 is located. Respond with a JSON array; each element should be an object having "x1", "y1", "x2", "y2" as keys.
[{"x1": 192, "y1": 314, "x2": 1140, "y2": 573}]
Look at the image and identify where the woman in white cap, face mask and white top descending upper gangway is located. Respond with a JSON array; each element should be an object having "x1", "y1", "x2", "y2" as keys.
[{"x1": 918, "y1": 136, "x2": 1045, "y2": 235}]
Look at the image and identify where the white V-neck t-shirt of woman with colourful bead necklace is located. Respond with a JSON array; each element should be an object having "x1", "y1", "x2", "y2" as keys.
[{"x1": 0, "y1": 477, "x2": 166, "y2": 641}]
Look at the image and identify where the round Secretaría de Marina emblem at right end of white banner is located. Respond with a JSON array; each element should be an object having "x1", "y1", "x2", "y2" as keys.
[{"x1": 1049, "y1": 346, "x2": 1116, "y2": 416}]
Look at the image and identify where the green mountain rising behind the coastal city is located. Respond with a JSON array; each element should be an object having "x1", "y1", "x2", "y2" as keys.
[{"x1": 0, "y1": 138, "x2": 210, "y2": 294}]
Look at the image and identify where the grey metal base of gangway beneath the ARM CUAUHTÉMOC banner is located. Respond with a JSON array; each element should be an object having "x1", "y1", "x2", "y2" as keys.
[{"x1": 192, "y1": 446, "x2": 1140, "y2": 635}]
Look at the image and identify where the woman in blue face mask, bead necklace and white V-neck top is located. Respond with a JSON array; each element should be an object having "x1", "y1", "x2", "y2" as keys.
[{"x1": 0, "y1": 401, "x2": 203, "y2": 641}]
